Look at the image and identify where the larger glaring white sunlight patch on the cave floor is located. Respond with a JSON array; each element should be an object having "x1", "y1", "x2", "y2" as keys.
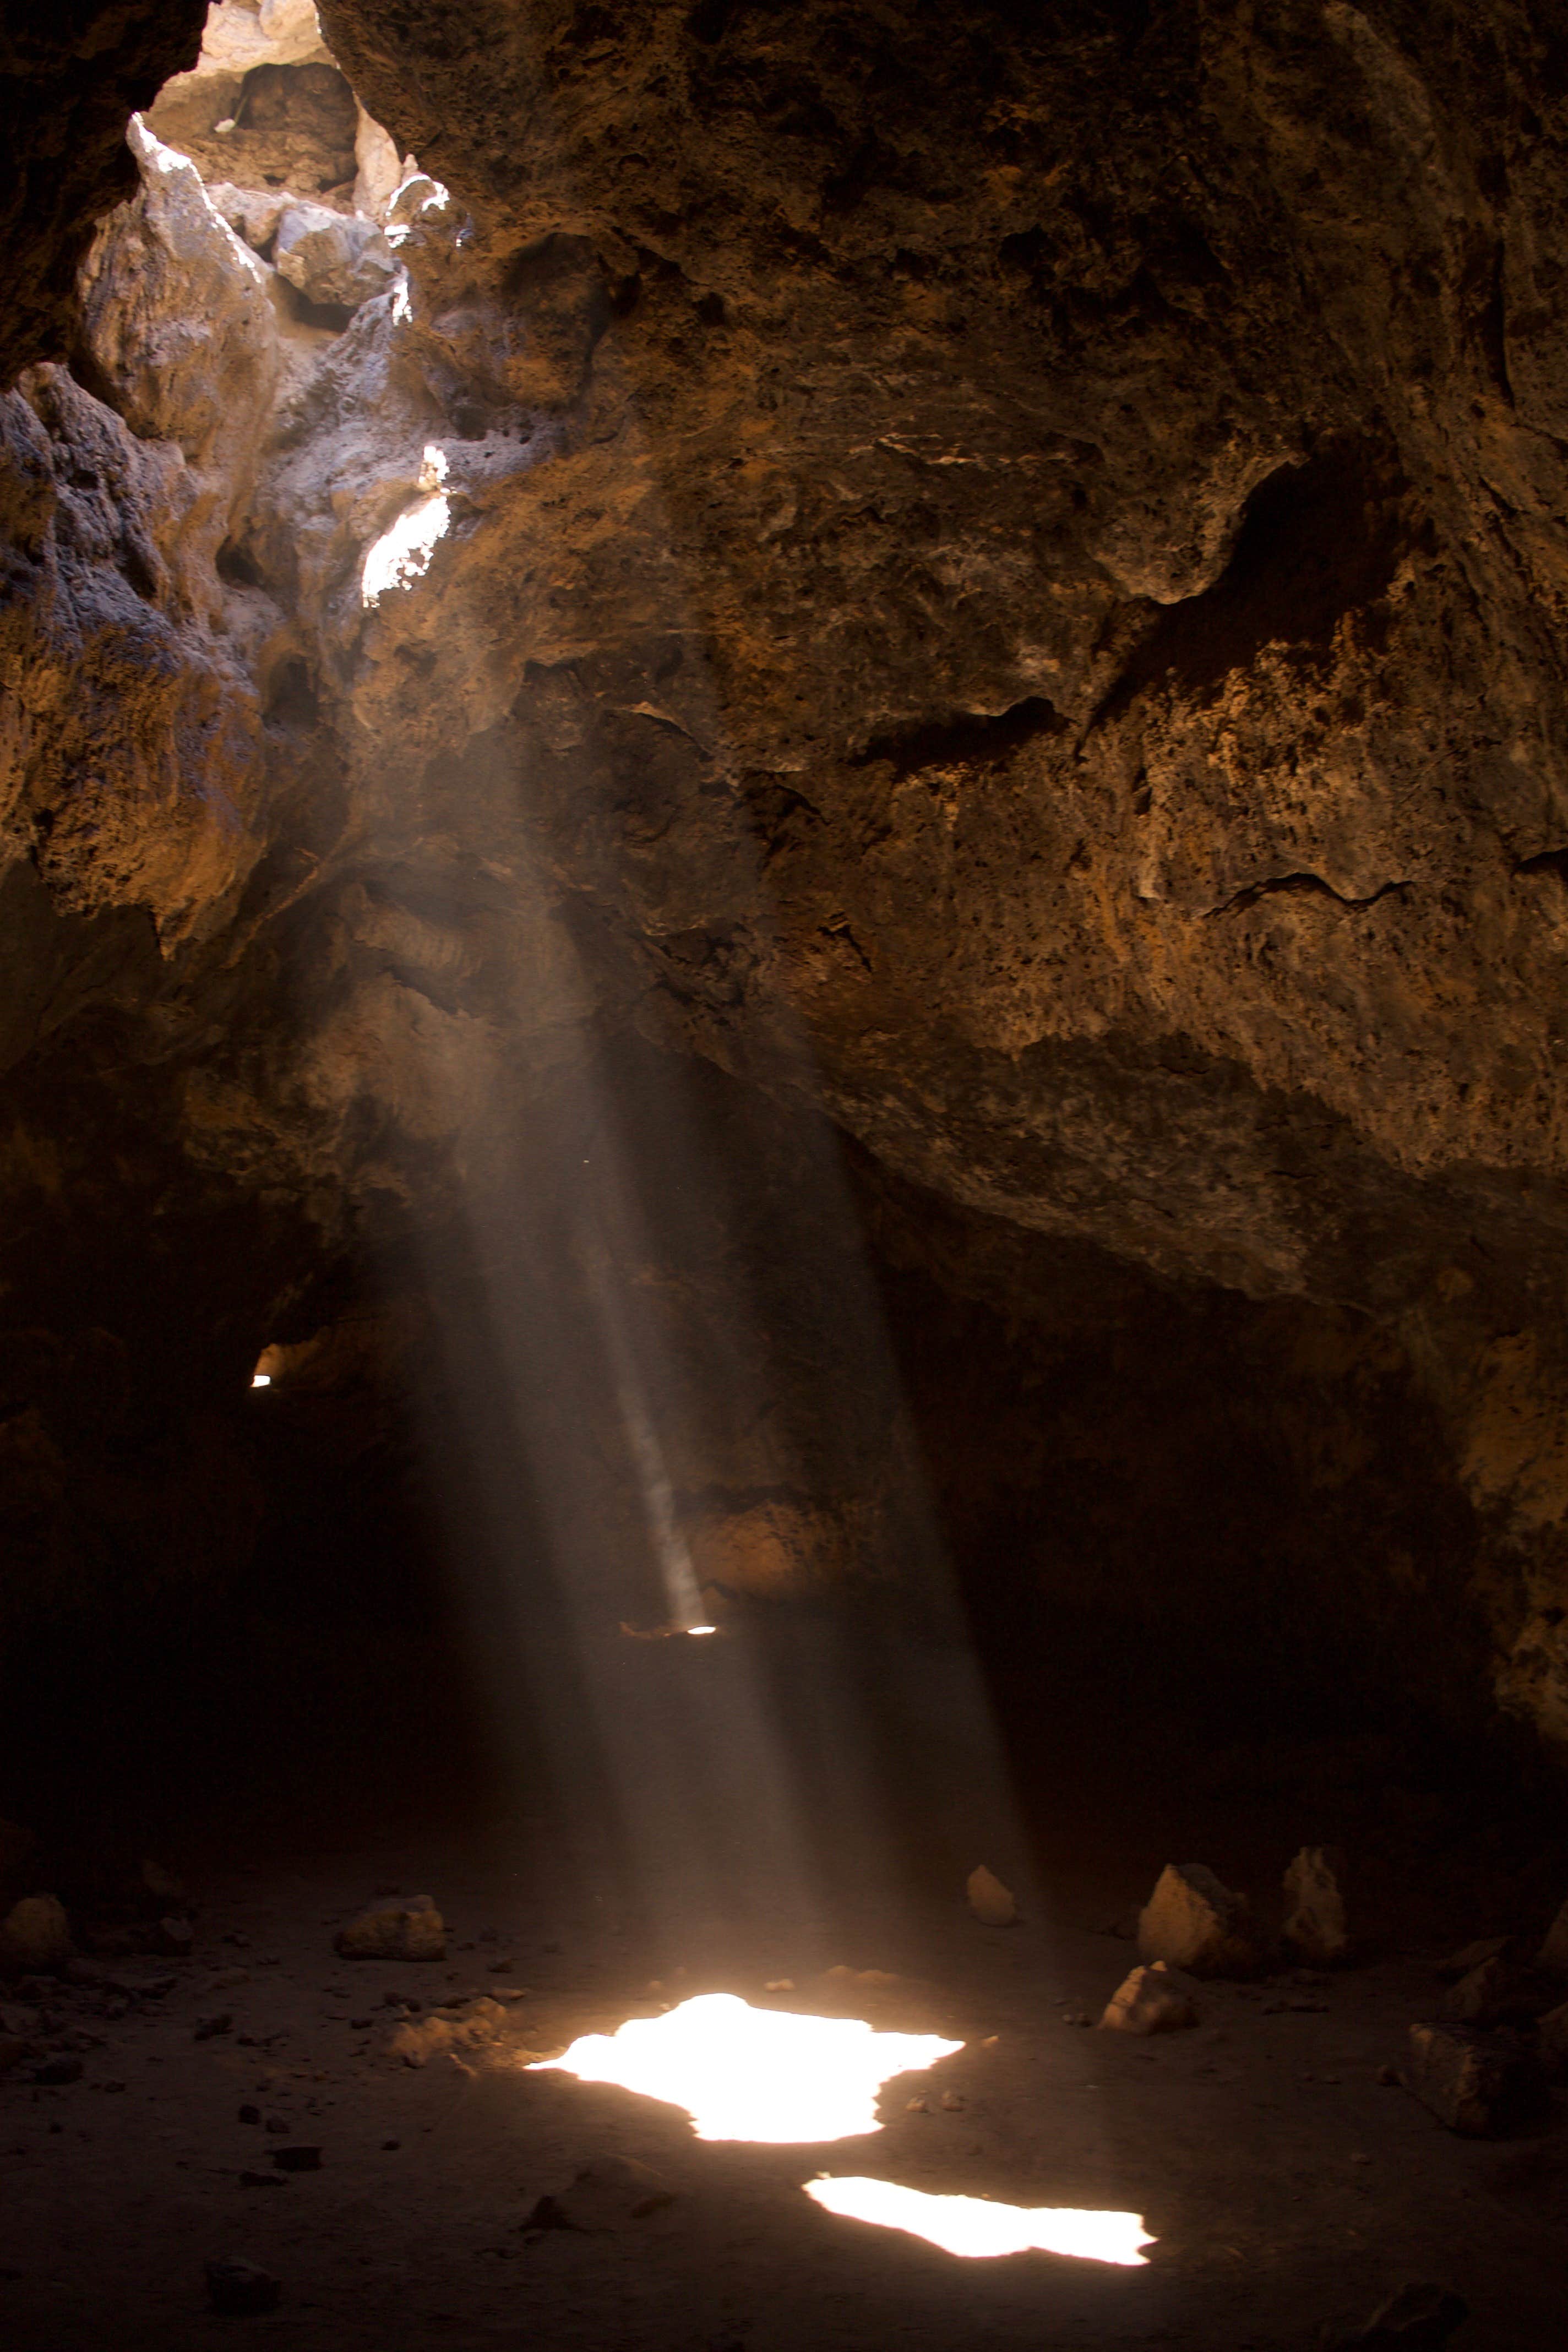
[{"x1": 529, "y1": 1992, "x2": 964, "y2": 2143}]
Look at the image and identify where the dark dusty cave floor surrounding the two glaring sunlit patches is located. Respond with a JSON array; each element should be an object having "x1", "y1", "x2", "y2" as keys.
[{"x1": 0, "y1": 1832, "x2": 1568, "y2": 2352}]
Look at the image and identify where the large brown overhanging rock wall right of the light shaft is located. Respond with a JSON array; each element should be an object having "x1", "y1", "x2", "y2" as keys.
[{"x1": 301, "y1": 0, "x2": 1568, "y2": 1729}]
